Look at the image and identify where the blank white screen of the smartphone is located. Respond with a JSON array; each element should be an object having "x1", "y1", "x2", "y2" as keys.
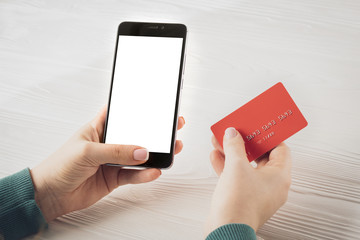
[{"x1": 106, "y1": 35, "x2": 182, "y2": 153}]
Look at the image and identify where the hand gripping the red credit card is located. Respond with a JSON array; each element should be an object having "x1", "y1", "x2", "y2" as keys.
[{"x1": 206, "y1": 128, "x2": 291, "y2": 235}]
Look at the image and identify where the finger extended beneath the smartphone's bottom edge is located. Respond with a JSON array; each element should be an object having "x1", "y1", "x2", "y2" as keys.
[{"x1": 117, "y1": 168, "x2": 161, "y2": 186}]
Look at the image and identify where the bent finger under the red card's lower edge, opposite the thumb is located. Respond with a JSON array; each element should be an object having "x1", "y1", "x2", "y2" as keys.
[{"x1": 266, "y1": 143, "x2": 291, "y2": 171}]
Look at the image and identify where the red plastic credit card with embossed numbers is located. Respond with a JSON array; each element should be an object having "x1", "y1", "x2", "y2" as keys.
[{"x1": 211, "y1": 82, "x2": 308, "y2": 162}]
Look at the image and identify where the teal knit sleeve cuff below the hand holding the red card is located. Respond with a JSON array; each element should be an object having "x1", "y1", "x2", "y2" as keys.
[{"x1": 206, "y1": 223, "x2": 256, "y2": 240}]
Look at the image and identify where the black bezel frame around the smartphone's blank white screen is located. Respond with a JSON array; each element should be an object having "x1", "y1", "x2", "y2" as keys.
[{"x1": 102, "y1": 22, "x2": 187, "y2": 169}]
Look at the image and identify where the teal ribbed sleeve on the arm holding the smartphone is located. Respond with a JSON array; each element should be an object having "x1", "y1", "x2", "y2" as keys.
[{"x1": 0, "y1": 168, "x2": 47, "y2": 240}]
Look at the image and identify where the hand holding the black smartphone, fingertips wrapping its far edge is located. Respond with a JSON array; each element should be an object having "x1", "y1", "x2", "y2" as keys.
[{"x1": 30, "y1": 108, "x2": 185, "y2": 222}]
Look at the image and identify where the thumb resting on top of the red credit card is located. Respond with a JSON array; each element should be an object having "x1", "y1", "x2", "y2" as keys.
[{"x1": 223, "y1": 127, "x2": 249, "y2": 168}]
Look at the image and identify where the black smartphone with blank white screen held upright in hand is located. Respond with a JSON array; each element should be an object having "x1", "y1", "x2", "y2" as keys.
[{"x1": 103, "y1": 22, "x2": 187, "y2": 168}]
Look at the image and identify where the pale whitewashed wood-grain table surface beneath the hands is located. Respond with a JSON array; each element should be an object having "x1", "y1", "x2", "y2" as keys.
[{"x1": 0, "y1": 0, "x2": 360, "y2": 239}]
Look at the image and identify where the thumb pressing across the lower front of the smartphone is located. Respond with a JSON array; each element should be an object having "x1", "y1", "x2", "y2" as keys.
[{"x1": 83, "y1": 142, "x2": 149, "y2": 165}]
